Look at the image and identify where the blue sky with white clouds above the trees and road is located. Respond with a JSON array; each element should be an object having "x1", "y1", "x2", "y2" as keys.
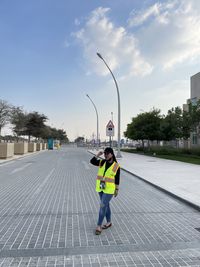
[{"x1": 0, "y1": 0, "x2": 200, "y2": 141}]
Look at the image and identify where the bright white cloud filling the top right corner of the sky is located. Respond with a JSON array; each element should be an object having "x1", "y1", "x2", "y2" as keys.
[{"x1": 128, "y1": 0, "x2": 200, "y2": 70}]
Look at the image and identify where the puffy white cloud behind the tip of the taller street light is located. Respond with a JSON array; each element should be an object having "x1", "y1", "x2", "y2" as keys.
[{"x1": 73, "y1": 7, "x2": 153, "y2": 77}]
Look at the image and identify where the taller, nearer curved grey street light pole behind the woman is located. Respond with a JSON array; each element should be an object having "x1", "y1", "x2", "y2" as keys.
[{"x1": 97, "y1": 53, "x2": 122, "y2": 158}]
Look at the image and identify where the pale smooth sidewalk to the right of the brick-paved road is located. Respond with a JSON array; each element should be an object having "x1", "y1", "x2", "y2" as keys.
[{"x1": 89, "y1": 151, "x2": 200, "y2": 213}]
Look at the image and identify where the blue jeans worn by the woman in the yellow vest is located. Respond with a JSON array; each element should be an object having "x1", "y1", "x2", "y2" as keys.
[{"x1": 97, "y1": 192, "x2": 113, "y2": 226}]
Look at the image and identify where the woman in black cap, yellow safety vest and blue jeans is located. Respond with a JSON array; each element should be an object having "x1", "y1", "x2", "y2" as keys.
[{"x1": 90, "y1": 147, "x2": 120, "y2": 235}]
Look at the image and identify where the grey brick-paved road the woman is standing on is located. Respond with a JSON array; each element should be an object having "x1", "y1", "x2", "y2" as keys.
[{"x1": 0, "y1": 147, "x2": 200, "y2": 267}]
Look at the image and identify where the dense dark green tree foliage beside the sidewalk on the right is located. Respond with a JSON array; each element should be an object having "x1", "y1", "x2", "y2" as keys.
[{"x1": 124, "y1": 100, "x2": 200, "y2": 147}]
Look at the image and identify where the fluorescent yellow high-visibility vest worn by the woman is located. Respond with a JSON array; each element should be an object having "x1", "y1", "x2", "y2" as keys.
[{"x1": 96, "y1": 160, "x2": 119, "y2": 194}]
